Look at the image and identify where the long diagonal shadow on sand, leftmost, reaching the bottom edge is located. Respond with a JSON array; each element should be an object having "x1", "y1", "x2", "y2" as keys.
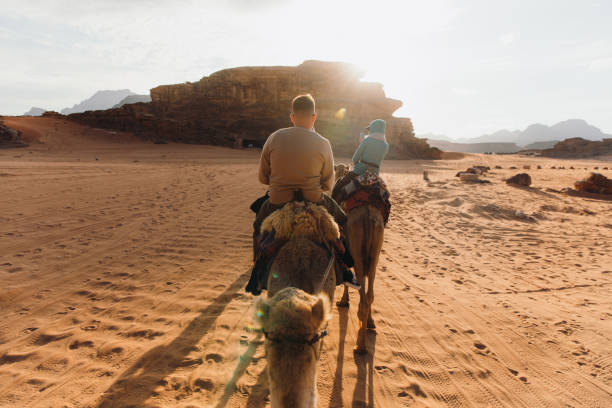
[{"x1": 97, "y1": 272, "x2": 248, "y2": 408}]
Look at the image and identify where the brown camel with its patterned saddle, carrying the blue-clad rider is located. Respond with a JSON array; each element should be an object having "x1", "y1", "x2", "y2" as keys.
[{"x1": 332, "y1": 164, "x2": 391, "y2": 354}]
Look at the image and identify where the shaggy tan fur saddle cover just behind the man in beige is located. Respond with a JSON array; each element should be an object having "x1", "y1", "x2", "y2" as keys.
[{"x1": 261, "y1": 201, "x2": 340, "y2": 243}]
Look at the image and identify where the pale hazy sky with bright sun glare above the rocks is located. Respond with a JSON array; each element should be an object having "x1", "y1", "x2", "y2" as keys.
[{"x1": 0, "y1": 0, "x2": 612, "y2": 137}]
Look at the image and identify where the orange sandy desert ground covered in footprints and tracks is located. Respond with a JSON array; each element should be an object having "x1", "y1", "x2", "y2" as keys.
[{"x1": 0, "y1": 118, "x2": 612, "y2": 407}]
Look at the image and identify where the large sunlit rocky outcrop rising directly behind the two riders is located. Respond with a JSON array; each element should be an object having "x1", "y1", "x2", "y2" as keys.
[{"x1": 69, "y1": 61, "x2": 442, "y2": 159}]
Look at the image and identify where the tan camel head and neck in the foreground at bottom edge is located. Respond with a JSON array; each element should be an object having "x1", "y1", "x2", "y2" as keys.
[{"x1": 256, "y1": 287, "x2": 330, "y2": 408}]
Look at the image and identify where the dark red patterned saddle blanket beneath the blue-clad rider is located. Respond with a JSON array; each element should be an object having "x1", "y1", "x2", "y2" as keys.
[{"x1": 332, "y1": 171, "x2": 391, "y2": 225}]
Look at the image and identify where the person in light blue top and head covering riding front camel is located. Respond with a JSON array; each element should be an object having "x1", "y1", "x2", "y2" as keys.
[{"x1": 353, "y1": 119, "x2": 389, "y2": 175}]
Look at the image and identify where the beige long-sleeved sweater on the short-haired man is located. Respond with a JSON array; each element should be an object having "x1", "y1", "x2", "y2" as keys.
[{"x1": 259, "y1": 126, "x2": 334, "y2": 204}]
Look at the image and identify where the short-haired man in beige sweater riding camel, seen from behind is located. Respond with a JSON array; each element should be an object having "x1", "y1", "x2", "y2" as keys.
[{"x1": 246, "y1": 94, "x2": 359, "y2": 294}]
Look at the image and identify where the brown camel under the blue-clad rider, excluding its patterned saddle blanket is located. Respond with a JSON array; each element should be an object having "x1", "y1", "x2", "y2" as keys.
[{"x1": 335, "y1": 164, "x2": 385, "y2": 354}]
